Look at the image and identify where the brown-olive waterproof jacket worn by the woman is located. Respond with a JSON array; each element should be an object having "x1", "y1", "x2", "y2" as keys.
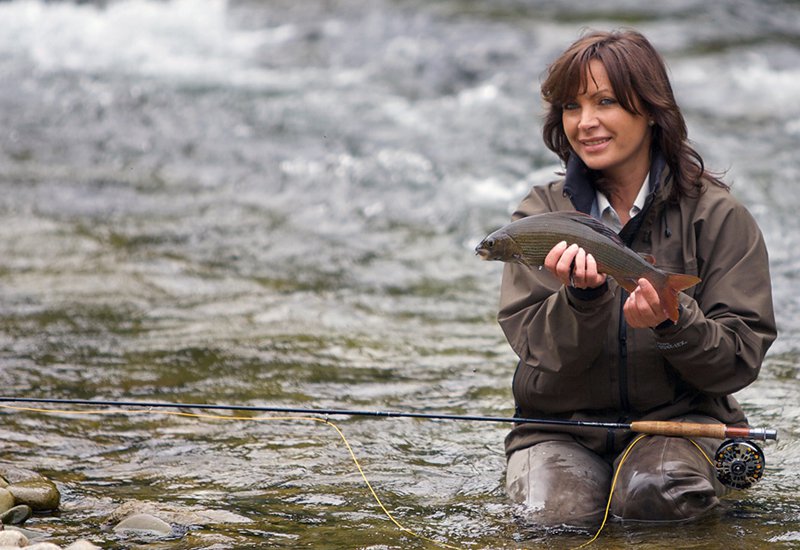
[{"x1": 498, "y1": 157, "x2": 776, "y2": 455}]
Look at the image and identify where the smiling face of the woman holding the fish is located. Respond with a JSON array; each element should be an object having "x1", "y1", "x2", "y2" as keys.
[{"x1": 561, "y1": 60, "x2": 652, "y2": 183}]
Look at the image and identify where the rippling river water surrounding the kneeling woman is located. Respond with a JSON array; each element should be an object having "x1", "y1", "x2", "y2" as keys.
[{"x1": 0, "y1": 0, "x2": 800, "y2": 549}]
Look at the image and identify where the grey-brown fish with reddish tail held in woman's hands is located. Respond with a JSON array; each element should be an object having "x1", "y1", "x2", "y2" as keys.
[{"x1": 475, "y1": 211, "x2": 701, "y2": 322}]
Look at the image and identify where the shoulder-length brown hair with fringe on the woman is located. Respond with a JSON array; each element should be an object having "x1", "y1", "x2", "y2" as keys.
[{"x1": 542, "y1": 30, "x2": 728, "y2": 200}]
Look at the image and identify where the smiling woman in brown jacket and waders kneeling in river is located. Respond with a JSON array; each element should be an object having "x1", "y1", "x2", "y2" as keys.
[{"x1": 498, "y1": 31, "x2": 776, "y2": 525}]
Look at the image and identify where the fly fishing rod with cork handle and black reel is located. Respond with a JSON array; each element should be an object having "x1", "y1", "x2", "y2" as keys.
[{"x1": 0, "y1": 396, "x2": 778, "y2": 489}]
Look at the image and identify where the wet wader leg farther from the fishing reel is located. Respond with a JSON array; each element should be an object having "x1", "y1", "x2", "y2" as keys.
[{"x1": 506, "y1": 441, "x2": 611, "y2": 527}]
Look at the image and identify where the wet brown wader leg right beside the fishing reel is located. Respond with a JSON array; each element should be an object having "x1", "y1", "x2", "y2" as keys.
[{"x1": 611, "y1": 419, "x2": 726, "y2": 521}]
